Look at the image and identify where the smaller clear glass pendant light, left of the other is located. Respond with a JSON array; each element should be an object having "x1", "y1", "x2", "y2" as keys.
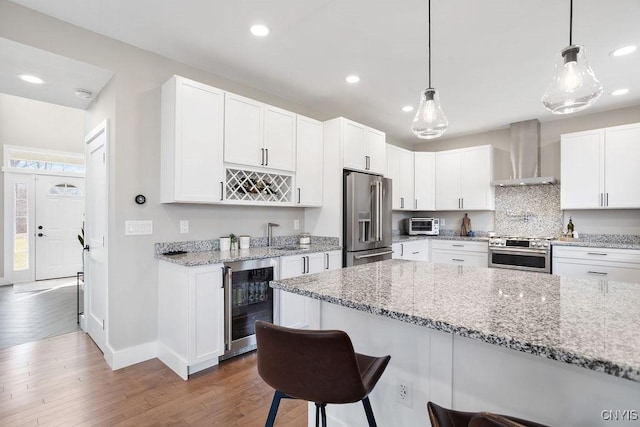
[{"x1": 411, "y1": 0, "x2": 449, "y2": 139}]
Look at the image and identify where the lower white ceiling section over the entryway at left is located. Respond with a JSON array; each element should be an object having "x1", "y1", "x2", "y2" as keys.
[{"x1": 0, "y1": 37, "x2": 113, "y2": 110}]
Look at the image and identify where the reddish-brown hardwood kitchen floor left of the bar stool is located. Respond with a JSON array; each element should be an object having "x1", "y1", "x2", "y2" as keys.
[{"x1": 0, "y1": 332, "x2": 307, "y2": 427}]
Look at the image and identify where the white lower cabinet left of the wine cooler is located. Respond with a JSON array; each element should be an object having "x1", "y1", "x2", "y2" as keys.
[{"x1": 158, "y1": 261, "x2": 224, "y2": 380}]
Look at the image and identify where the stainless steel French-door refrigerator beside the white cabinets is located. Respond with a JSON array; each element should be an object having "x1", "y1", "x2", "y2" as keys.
[{"x1": 342, "y1": 170, "x2": 392, "y2": 267}]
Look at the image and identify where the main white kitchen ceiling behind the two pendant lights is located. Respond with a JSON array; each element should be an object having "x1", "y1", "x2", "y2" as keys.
[{"x1": 6, "y1": 0, "x2": 640, "y2": 143}]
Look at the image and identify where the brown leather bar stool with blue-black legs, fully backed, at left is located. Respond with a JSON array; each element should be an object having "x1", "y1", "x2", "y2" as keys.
[{"x1": 256, "y1": 320, "x2": 391, "y2": 427}]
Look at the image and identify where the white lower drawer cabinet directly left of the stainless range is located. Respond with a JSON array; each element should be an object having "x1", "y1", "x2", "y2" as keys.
[{"x1": 431, "y1": 240, "x2": 489, "y2": 267}]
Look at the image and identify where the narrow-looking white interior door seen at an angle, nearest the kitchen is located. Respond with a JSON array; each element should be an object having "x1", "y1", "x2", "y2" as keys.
[{"x1": 83, "y1": 120, "x2": 109, "y2": 353}]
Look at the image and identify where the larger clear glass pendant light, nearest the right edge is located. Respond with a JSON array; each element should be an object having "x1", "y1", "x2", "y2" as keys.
[{"x1": 542, "y1": 0, "x2": 602, "y2": 114}]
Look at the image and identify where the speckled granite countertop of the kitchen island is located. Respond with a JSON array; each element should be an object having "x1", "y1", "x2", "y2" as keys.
[{"x1": 271, "y1": 260, "x2": 640, "y2": 382}]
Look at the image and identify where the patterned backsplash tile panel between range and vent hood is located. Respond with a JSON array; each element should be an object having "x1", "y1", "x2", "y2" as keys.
[{"x1": 495, "y1": 185, "x2": 562, "y2": 237}]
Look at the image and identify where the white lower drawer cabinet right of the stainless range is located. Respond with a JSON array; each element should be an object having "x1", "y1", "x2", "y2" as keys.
[{"x1": 551, "y1": 246, "x2": 640, "y2": 283}]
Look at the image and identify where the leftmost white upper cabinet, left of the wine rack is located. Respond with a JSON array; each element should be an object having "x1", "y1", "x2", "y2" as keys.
[{"x1": 160, "y1": 76, "x2": 224, "y2": 203}]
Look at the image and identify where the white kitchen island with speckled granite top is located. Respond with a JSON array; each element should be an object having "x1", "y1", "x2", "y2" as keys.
[{"x1": 272, "y1": 260, "x2": 640, "y2": 426}]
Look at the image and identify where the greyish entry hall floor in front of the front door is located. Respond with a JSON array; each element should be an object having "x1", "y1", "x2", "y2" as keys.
[{"x1": 0, "y1": 278, "x2": 82, "y2": 348}]
